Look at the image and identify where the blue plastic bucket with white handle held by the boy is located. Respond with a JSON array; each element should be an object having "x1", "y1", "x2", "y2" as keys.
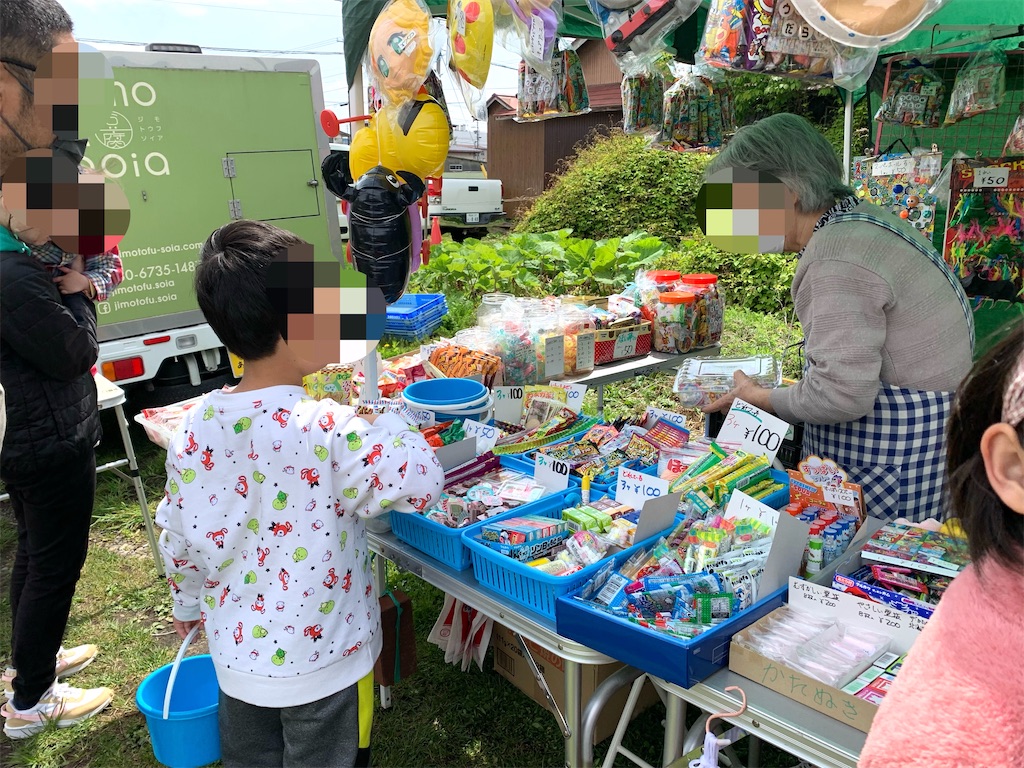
[{"x1": 135, "y1": 631, "x2": 220, "y2": 768}]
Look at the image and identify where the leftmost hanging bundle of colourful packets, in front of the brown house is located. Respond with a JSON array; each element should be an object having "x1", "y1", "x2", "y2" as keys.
[{"x1": 515, "y1": 48, "x2": 590, "y2": 123}]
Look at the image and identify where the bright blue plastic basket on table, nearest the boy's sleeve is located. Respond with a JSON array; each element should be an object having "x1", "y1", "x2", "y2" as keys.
[{"x1": 391, "y1": 488, "x2": 580, "y2": 570}]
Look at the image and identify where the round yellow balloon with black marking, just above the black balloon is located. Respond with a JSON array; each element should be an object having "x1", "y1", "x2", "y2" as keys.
[{"x1": 376, "y1": 93, "x2": 449, "y2": 179}]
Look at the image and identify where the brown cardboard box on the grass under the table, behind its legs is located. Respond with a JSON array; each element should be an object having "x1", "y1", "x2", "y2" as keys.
[{"x1": 490, "y1": 624, "x2": 659, "y2": 744}]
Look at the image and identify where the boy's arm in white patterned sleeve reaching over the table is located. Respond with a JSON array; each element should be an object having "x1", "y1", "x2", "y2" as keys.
[{"x1": 332, "y1": 414, "x2": 444, "y2": 517}]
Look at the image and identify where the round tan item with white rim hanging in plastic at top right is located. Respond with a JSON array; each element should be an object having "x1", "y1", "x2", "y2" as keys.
[{"x1": 792, "y1": 0, "x2": 945, "y2": 48}]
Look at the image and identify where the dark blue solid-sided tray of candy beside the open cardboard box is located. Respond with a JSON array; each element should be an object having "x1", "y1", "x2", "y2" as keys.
[{"x1": 555, "y1": 550, "x2": 788, "y2": 688}]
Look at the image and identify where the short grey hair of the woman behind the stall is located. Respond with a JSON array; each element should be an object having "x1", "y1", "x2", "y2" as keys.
[{"x1": 705, "y1": 113, "x2": 853, "y2": 213}]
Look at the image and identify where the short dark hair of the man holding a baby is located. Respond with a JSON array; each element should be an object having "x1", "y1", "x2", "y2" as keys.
[{"x1": 0, "y1": 0, "x2": 75, "y2": 95}]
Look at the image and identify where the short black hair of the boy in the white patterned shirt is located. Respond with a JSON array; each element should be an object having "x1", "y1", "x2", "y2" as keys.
[{"x1": 196, "y1": 220, "x2": 304, "y2": 360}]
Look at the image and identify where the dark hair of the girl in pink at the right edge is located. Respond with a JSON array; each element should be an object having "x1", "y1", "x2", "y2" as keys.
[{"x1": 946, "y1": 321, "x2": 1024, "y2": 568}]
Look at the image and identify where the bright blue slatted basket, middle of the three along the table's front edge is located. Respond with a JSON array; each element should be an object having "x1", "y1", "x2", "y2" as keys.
[{"x1": 462, "y1": 488, "x2": 678, "y2": 622}]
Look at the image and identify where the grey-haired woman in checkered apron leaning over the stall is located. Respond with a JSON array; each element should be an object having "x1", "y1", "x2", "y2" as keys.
[{"x1": 708, "y1": 114, "x2": 974, "y2": 520}]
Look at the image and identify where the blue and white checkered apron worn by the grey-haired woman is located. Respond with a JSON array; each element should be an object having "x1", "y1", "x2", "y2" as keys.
[{"x1": 804, "y1": 212, "x2": 974, "y2": 521}]
